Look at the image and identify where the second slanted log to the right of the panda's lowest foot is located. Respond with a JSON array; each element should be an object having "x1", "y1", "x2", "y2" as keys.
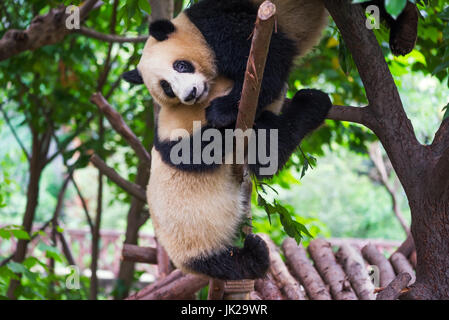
[{"x1": 282, "y1": 238, "x2": 332, "y2": 300}]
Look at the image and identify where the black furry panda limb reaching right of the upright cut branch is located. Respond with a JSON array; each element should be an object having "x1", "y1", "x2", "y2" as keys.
[{"x1": 249, "y1": 89, "x2": 332, "y2": 179}]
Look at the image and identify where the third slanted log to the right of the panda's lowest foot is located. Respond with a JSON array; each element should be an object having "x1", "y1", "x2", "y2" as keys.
[{"x1": 308, "y1": 239, "x2": 357, "y2": 300}]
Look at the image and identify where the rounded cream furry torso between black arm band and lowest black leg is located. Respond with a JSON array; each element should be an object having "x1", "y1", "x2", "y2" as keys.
[{"x1": 147, "y1": 149, "x2": 241, "y2": 266}]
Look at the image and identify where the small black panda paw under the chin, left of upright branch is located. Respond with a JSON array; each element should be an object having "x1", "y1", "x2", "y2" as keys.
[{"x1": 206, "y1": 98, "x2": 238, "y2": 128}]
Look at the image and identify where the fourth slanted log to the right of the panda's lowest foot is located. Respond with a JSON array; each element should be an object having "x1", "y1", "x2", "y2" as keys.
[{"x1": 336, "y1": 244, "x2": 375, "y2": 300}]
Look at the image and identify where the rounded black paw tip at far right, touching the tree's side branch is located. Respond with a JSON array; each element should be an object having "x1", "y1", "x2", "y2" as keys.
[{"x1": 290, "y1": 89, "x2": 332, "y2": 120}]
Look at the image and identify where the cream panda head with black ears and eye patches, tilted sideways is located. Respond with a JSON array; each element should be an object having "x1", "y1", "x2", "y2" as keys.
[{"x1": 123, "y1": 14, "x2": 217, "y2": 106}]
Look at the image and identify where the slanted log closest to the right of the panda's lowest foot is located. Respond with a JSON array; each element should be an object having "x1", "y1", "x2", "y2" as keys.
[{"x1": 259, "y1": 234, "x2": 305, "y2": 300}]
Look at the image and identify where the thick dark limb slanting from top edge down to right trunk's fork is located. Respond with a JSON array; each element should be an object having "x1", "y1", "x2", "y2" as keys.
[{"x1": 324, "y1": 0, "x2": 428, "y2": 192}]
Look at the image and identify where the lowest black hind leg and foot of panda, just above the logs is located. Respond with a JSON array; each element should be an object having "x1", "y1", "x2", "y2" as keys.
[{"x1": 187, "y1": 234, "x2": 270, "y2": 280}]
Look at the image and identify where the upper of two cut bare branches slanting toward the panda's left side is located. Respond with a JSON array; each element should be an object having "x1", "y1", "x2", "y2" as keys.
[{"x1": 90, "y1": 93, "x2": 151, "y2": 168}]
